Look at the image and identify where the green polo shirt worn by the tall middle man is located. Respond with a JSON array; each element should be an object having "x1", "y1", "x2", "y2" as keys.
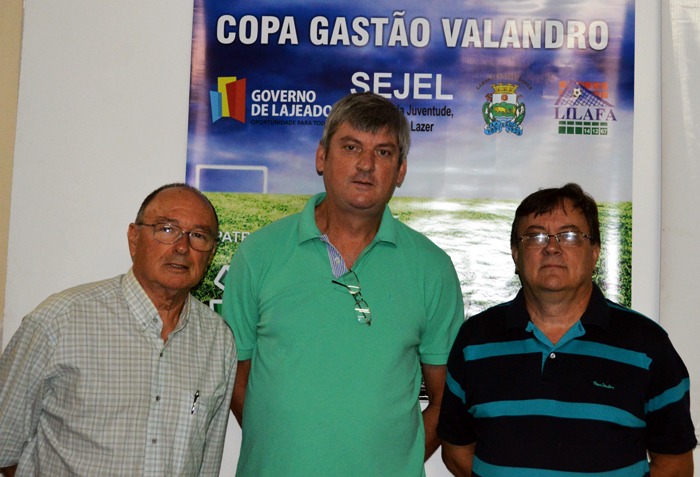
[{"x1": 223, "y1": 194, "x2": 464, "y2": 477}]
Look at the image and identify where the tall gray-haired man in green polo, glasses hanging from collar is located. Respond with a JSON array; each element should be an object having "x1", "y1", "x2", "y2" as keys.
[{"x1": 223, "y1": 93, "x2": 464, "y2": 477}]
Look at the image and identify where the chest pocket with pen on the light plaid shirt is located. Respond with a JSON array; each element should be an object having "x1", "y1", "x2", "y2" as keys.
[{"x1": 173, "y1": 392, "x2": 220, "y2": 475}]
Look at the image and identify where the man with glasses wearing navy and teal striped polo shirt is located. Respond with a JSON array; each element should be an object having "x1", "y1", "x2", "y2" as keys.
[{"x1": 438, "y1": 184, "x2": 697, "y2": 477}]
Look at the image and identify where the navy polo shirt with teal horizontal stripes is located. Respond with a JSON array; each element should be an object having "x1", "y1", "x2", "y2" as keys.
[{"x1": 438, "y1": 285, "x2": 697, "y2": 477}]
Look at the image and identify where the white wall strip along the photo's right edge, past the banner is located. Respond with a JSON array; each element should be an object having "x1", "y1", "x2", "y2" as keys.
[{"x1": 660, "y1": 0, "x2": 700, "y2": 438}]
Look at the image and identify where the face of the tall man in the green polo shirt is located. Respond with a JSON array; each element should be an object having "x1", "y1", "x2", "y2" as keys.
[{"x1": 316, "y1": 123, "x2": 406, "y2": 214}]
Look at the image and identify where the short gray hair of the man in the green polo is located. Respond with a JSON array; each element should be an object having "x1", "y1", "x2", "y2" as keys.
[{"x1": 321, "y1": 91, "x2": 411, "y2": 165}]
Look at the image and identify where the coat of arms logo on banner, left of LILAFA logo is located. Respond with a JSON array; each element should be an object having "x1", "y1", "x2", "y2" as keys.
[{"x1": 481, "y1": 83, "x2": 525, "y2": 136}]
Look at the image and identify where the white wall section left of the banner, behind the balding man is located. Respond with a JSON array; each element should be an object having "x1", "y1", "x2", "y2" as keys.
[{"x1": 4, "y1": 0, "x2": 192, "y2": 343}]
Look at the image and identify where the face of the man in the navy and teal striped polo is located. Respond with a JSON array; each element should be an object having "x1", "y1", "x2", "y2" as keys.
[{"x1": 512, "y1": 200, "x2": 600, "y2": 295}]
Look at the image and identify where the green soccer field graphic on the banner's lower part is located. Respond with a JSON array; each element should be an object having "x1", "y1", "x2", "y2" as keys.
[{"x1": 195, "y1": 193, "x2": 632, "y2": 316}]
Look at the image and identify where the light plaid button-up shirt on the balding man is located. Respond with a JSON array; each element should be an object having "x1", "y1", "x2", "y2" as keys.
[{"x1": 0, "y1": 271, "x2": 236, "y2": 477}]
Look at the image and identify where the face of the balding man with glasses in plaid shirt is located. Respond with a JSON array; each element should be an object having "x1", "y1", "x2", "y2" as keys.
[{"x1": 128, "y1": 188, "x2": 216, "y2": 299}]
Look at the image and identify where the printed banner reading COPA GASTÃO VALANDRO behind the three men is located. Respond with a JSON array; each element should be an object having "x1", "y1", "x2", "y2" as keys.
[{"x1": 187, "y1": 0, "x2": 634, "y2": 315}]
